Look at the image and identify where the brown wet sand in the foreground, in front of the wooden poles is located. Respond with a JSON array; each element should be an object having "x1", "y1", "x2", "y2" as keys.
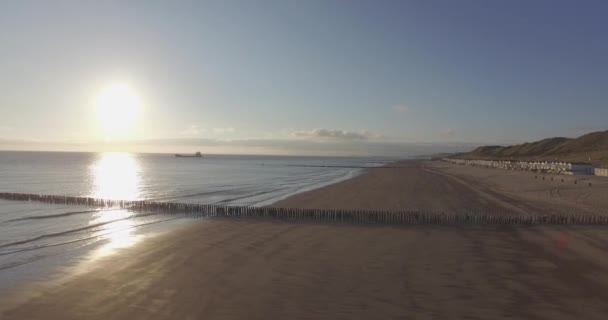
[{"x1": 1, "y1": 219, "x2": 608, "y2": 319}]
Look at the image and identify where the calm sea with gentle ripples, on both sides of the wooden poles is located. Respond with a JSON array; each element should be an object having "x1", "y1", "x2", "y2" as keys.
[{"x1": 0, "y1": 151, "x2": 394, "y2": 290}]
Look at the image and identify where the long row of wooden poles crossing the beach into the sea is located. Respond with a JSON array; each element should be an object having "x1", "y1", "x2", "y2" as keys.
[{"x1": 0, "y1": 192, "x2": 608, "y2": 225}]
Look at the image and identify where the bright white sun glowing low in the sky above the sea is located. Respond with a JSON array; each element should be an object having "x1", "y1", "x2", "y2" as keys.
[{"x1": 95, "y1": 83, "x2": 141, "y2": 139}]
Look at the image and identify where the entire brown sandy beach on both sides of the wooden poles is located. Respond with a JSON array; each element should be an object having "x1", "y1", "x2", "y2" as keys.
[{"x1": 0, "y1": 162, "x2": 608, "y2": 319}]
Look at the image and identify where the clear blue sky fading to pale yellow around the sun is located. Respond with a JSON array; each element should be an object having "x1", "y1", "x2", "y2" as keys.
[{"x1": 0, "y1": 0, "x2": 608, "y2": 155}]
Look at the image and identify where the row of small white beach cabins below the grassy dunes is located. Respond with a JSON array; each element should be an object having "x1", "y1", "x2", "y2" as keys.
[{"x1": 443, "y1": 158, "x2": 608, "y2": 177}]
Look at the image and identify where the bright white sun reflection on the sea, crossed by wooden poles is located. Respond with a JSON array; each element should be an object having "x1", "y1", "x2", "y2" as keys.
[{"x1": 89, "y1": 153, "x2": 141, "y2": 257}]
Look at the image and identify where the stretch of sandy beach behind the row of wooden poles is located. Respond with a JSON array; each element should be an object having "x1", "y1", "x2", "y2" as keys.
[{"x1": 274, "y1": 161, "x2": 608, "y2": 214}]
